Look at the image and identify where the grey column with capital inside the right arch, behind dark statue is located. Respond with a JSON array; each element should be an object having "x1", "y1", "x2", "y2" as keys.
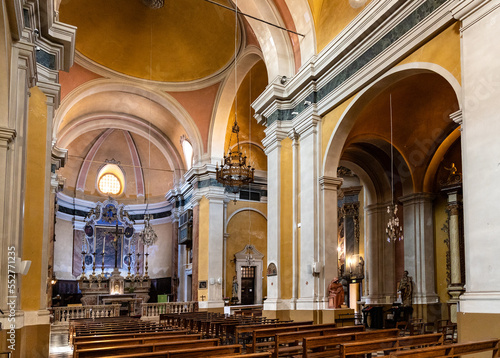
[{"x1": 399, "y1": 193, "x2": 441, "y2": 321}]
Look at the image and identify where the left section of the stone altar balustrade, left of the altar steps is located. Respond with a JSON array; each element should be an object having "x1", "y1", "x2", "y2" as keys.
[{"x1": 50, "y1": 304, "x2": 120, "y2": 325}]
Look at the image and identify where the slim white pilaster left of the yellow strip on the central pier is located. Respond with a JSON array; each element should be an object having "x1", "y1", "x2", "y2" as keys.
[{"x1": 262, "y1": 121, "x2": 289, "y2": 311}]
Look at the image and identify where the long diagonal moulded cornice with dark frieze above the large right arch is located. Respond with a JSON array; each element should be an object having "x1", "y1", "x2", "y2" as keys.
[{"x1": 253, "y1": 0, "x2": 453, "y2": 125}]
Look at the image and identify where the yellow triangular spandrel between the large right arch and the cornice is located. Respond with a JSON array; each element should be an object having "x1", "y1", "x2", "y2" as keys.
[{"x1": 398, "y1": 22, "x2": 462, "y2": 83}]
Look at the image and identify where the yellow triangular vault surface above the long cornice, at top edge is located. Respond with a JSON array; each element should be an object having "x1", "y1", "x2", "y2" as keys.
[{"x1": 308, "y1": 0, "x2": 371, "y2": 52}]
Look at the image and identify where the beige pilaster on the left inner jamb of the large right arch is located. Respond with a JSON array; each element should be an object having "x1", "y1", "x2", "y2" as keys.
[{"x1": 319, "y1": 176, "x2": 342, "y2": 309}]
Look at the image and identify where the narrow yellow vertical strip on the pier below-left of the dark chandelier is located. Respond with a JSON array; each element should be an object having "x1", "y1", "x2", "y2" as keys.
[{"x1": 198, "y1": 197, "x2": 210, "y2": 301}]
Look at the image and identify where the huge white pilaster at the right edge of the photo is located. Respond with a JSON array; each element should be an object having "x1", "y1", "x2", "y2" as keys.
[{"x1": 454, "y1": 0, "x2": 500, "y2": 314}]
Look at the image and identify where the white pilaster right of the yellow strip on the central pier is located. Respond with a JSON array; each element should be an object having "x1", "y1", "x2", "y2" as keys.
[{"x1": 295, "y1": 115, "x2": 323, "y2": 310}]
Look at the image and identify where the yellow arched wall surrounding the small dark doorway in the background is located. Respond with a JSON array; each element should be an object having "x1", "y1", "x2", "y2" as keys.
[{"x1": 225, "y1": 208, "x2": 267, "y2": 297}]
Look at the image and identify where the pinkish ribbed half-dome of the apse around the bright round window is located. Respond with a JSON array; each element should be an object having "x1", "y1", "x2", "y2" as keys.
[{"x1": 59, "y1": 129, "x2": 174, "y2": 204}]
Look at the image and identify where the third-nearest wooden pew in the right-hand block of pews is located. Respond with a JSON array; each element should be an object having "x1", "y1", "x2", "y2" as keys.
[{"x1": 302, "y1": 327, "x2": 399, "y2": 358}]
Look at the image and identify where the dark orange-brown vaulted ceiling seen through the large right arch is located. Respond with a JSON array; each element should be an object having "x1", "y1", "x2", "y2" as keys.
[{"x1": 344, "y1": 73, "x2": 458, "y2": 191}]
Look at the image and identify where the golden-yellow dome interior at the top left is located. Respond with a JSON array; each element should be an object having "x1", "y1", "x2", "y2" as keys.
[{"x1": 59, "y1": 0, "x2": 241, "y2": 82}]
